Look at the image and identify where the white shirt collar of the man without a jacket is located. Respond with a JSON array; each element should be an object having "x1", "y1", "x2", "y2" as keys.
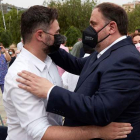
[{"x1": 20, "y1": 48, "x2": 52, "y2": 72}]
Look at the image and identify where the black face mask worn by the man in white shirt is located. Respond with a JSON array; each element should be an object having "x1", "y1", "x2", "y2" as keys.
[{"x1": 43, "y1": 31, "x2": 63, "y2": 54}]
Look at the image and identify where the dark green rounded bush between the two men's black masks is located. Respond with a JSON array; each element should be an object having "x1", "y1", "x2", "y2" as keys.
[{"x1": 65, "y1": 26, "x2": 82, "y2": 46}]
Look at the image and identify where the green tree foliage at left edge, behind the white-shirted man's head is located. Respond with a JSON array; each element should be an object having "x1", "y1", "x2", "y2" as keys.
[{"x1": 0, "y1": 8, "x2": 23, "y2": 47}]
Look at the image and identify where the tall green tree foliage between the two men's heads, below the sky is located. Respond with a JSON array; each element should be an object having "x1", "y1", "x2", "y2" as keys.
[{"x1": 48, "y1": 0, "x2": 96, "y2": 34}]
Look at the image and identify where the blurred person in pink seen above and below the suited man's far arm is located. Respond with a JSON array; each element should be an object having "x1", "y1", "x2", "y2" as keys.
[{"x1": 57, "y1": 35, "x2": 69, "y2": 76}]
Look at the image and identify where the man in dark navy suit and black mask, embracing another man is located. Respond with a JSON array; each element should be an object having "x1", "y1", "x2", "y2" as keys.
[{"x1": 18, "y1": 3, "x2": 140, "y2": 140}]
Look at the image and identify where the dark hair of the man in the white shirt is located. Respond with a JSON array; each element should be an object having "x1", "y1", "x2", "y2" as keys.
[{"x1": 21, "y1": 5, "x2": 58, "y2": 44}]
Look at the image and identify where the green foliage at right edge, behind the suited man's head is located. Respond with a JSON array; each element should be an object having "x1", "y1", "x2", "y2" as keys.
[{"x1": 127, "y1": 6, "x2": 140, "y2": 33}]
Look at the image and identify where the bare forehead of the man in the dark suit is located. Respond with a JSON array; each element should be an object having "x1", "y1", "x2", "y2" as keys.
[{"x1": 90, "y1": 8, "x2": 104, "y2": 22}]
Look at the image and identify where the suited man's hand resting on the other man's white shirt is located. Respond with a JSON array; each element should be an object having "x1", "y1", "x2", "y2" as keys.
[{"x1": 16, "y1": 70, "x2": 54, "y2": 98}]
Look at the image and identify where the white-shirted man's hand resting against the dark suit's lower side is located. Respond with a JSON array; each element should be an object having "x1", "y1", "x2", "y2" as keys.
[{"x1": 97, "y1": 122, "x2": 133, "y2": 140}]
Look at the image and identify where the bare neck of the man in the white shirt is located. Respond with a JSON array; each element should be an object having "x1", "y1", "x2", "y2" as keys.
[{"x1": 24, "y1": 43, "x2": 47, "y2": 62}]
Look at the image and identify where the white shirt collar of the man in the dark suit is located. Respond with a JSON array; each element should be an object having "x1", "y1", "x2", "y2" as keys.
[{"x1": 97, "y1": 35, "x2": 127, "y2": 58}]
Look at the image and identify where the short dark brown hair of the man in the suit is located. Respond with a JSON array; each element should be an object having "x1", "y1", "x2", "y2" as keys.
[{"x1": 95, "y1": 2, "x2": 128, "y2": 35}]
